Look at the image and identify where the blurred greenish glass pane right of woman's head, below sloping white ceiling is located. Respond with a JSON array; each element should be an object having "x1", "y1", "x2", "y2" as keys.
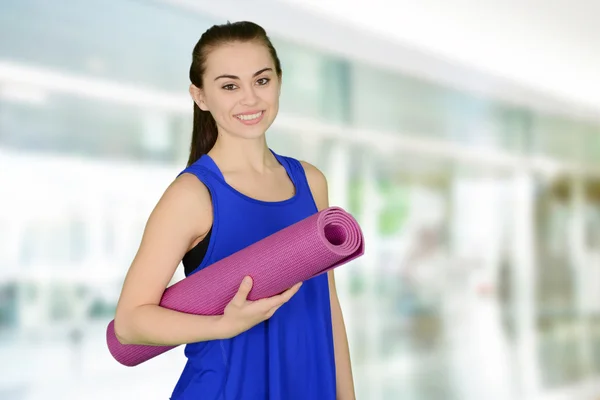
[{"x1": 352, "y1": 64, "x2": 526, "y2": 151}]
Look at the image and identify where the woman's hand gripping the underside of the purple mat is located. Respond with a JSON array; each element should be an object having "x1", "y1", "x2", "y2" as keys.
[{"x1": 222, "y1": 276, "x2": 302, "y2": 337}]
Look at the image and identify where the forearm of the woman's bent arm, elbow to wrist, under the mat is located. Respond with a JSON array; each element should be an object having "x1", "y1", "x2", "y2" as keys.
[{"x1": 115, "y1": 305, "x2": 229, "y2": 346}]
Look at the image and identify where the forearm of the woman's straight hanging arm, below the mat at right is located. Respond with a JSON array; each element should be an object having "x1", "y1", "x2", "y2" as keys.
[{"x1": 331, "y1": 297, "x2": 356, "y2": 400}]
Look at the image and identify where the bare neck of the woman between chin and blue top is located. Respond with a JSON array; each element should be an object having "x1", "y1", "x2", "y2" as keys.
[{"x1": 209, "y1": 135, "x2": 274, "y2": 172}]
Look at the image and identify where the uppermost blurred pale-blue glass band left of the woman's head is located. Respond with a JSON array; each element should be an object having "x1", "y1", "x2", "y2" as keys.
[{"x1": 0, "y1": 0, "x2": 212, "y2": 91}]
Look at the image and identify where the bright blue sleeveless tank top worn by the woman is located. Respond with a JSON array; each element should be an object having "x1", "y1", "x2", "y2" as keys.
[{"x1": 171, "y1": 152, "x2": 336, "y2": 400}]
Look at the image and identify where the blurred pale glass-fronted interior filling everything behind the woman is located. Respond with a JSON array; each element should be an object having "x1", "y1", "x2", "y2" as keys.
[{"x1": 0, "y1": 0, "x2": 600, "y2": 400}]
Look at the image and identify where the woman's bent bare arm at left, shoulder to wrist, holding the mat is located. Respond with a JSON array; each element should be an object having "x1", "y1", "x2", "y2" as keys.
[{"x1": 115, "y1": 174, "x2": 231, "y2": 345}]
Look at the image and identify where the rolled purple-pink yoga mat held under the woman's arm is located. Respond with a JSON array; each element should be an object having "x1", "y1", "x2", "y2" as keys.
[{"x1": 106, "y1": 207, "x2": 364, "y2": 367}]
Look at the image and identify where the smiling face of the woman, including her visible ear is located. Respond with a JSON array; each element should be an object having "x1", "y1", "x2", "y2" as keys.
[{"x1": 191, "y1": 42, "x2": 281, "y2": 138}]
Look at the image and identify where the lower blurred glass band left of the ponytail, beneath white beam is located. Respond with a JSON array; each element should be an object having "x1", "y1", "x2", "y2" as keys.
[{"x1": 0, "y1": 95, "x2": 180, "y2": 162}]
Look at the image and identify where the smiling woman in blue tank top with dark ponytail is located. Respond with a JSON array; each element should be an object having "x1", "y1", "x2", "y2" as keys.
[{"x1": 115, "y1": 22, "x2": 355, "y2": 400}]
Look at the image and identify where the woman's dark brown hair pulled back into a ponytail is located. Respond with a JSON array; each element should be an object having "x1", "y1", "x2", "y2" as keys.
[{"x1": 187, "y1": 21, "x2": 282, "y2": 166}]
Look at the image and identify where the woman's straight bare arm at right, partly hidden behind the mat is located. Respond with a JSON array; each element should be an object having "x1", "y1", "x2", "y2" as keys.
[{"x1": 302, "y1": 161, "x2": 356, "y2": 400}]
